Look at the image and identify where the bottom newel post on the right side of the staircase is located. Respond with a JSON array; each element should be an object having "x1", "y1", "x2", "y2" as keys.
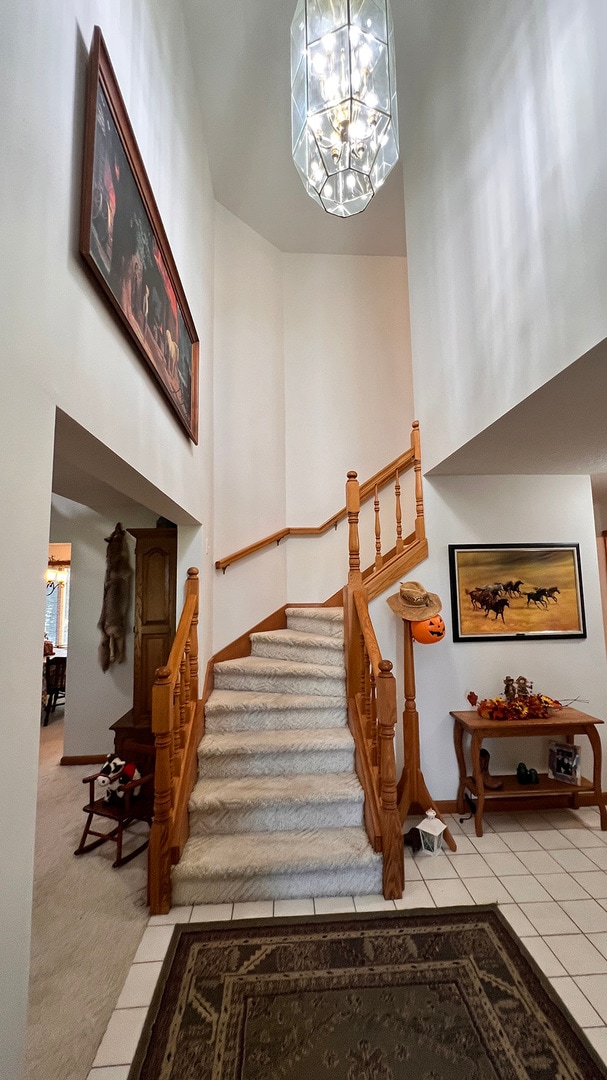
[{"x1": 377, "y1": 660, "x2": 405, "y2": 900}]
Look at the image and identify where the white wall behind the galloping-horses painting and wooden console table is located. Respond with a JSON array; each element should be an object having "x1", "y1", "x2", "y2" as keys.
[{"x1": 372, "y1": 476, "x2": 607, "y2": 799}]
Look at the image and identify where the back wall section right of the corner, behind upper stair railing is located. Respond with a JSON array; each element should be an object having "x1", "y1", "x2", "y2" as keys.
[{"x1": 283, "y1": 255, "x2": 414, "y2": 603}]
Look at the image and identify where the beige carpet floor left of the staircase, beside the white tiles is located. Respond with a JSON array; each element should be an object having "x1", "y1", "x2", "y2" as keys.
[{"x1": 26, "y1": 708, "x2": 148, "y2": 1080}]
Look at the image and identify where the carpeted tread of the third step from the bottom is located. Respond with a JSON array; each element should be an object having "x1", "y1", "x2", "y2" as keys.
[{"x1": 198, "y1": 727, "x2": 354, "y2": 758}]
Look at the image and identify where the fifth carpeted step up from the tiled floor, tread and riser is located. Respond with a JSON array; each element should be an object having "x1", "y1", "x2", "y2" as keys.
[{"x1": 214, "y1": 657, "x2": 346, "y2": 697}]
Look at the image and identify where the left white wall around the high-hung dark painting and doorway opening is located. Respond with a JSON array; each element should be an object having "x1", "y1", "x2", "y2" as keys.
[{"x1": 0, "y1": 0, "x2": 213, "y2": 1080}]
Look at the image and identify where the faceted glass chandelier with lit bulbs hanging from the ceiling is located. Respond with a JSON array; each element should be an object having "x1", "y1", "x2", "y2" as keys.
[{"x1": 291, "y1": 0, "x2": 399, "y2": 217}]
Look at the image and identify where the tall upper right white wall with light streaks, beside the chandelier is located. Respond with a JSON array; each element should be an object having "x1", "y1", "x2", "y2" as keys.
[{"x1": 403, "y1": 0, "x2": 607, "y2": 468}]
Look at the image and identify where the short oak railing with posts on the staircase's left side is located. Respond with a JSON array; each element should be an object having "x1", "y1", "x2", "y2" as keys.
[{"x1": 148, "y1": 567, "x2": 203, "y2": 915}]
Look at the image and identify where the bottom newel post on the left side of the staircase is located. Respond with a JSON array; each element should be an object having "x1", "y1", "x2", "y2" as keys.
[{"x1": 148, "y1": 667, "x2": 173, "y2": 915}]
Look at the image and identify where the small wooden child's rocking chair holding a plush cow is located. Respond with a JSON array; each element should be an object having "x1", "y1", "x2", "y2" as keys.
[{"x1": 73, "y1": 746, "x2": 153, "y2": 867}]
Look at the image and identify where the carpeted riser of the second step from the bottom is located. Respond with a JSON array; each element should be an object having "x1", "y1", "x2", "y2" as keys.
[{"x1": 190, "y1": 801, "x2": 363, "y2": 836}]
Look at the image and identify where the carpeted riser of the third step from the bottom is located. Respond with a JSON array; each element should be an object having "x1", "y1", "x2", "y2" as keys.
[{"x1": 198, "y1": 750, "x2": 354, "y2": 780}]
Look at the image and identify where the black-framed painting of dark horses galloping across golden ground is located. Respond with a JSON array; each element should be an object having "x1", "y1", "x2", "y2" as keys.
[{"x1": 449, "y1": 543, "x2": 586, "y2": 642}]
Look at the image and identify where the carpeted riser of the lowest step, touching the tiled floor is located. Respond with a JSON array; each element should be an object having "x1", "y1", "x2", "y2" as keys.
[{"x1": 173, "y1": 867, "x2": 381, "y2": 906}]
